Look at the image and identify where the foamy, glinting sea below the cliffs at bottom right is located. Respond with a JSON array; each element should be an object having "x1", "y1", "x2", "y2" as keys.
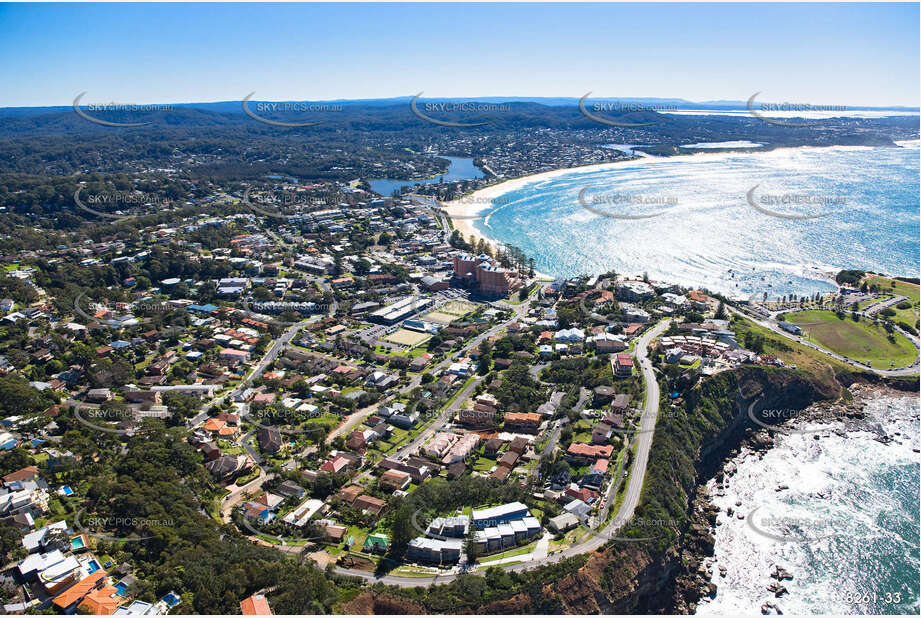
[{"x1": 697, "y1": 396, "x2": 921, "y2": 615}]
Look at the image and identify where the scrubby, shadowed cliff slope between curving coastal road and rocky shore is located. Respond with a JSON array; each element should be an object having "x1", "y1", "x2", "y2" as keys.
[{"x1": 366, "y1": 367, "x2": 842, "y2": 615}]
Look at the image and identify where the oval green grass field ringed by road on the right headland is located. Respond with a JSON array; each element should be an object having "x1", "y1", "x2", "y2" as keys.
[{"x1": 787, "y1": 310, "x2": 917, "y2": 369}]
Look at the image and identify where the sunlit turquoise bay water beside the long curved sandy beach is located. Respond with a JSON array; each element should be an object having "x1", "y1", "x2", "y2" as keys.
[{"x1": 473, "y1": 142, "x2": 921, "y2": 298}]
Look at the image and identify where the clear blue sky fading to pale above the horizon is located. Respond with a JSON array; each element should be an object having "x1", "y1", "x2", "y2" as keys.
[{"x1": 0, "y1": 3, "x2": 921, "y2": 107}]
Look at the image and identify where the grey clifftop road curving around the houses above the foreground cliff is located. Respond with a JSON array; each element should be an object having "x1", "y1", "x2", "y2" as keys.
[{"x1": 333, "y1": 321, "x2": 669, "y2": 588}]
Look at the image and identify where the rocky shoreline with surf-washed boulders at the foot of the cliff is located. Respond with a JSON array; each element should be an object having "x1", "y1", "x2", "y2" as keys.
[{"x1": 673, "y1": 383, "x2": 918, "y2": 614}]
